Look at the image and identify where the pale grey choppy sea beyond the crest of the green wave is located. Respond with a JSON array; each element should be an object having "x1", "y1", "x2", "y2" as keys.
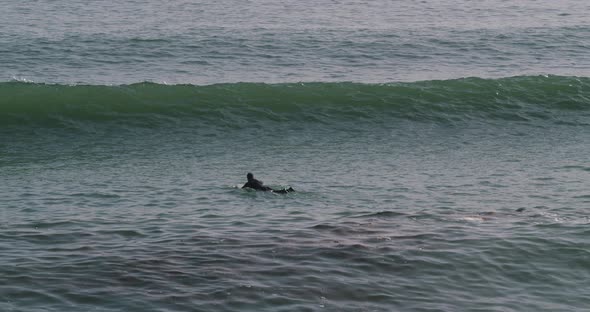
[{"x1": 0, "y1": 0, "x2": 590, "y2": 84}]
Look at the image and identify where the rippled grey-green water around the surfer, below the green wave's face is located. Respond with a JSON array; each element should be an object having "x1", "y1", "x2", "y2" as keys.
[{"x1": 0, "y1": 111, "x2": 590, "y2": 311}]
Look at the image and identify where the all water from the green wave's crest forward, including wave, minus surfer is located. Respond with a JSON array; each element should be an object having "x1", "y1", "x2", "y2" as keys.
[{"x1": 0, "y1": 76, "x2": 590, "y2": 311}]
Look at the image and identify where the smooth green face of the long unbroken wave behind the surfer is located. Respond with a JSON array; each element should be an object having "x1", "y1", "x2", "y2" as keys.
[{"x1": 0, "y1": 76, "x2": 590, "y2": 128}]
